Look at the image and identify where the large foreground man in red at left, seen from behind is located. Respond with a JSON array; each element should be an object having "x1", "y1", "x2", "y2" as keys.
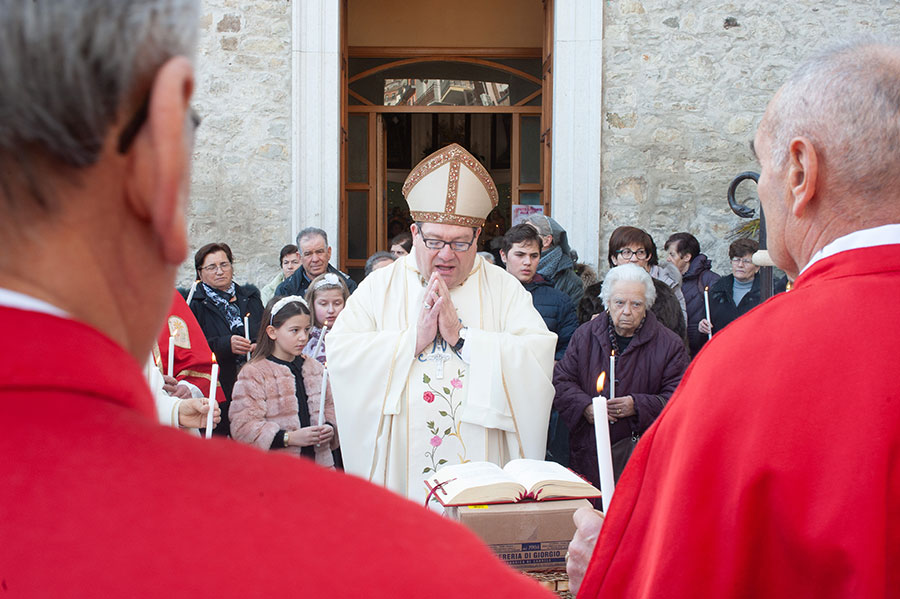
[{"x1": 0, "y1": 0, "x2": 545, "y2": 598}]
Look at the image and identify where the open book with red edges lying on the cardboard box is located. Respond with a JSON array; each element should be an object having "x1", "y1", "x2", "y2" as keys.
[{"x1": 425, "y1": 460, "x2": 600, "y2": 507}]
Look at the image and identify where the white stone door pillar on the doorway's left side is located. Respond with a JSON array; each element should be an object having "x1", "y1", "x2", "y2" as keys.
[{"x1": 291, "y1": 0, "x2": 341, "y2": 264}]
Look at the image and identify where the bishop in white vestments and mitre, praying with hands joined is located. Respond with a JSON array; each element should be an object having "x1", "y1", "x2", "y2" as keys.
[{"x1": 328, "y1": 145, "x2": 556, "y2": 502}]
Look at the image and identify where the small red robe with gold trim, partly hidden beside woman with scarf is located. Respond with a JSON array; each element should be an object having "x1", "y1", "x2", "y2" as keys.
[{"x1": 153, "y1": 290, "x2": 225, "y2": 403}]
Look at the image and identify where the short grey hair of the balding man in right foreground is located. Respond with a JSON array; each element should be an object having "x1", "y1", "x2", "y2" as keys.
[{"x1": 766, "y1": 37, "x2": 900, "y2": 194}]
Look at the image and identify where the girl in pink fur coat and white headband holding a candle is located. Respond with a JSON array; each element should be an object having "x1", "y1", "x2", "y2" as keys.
[{"x1": 231, "y1": 296, "x2": 338, "y2": 468}]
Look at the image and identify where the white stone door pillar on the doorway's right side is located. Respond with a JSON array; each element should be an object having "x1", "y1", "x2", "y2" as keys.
[{"x1": 551, "y1": 0, "x2": 604, "y2": 270}]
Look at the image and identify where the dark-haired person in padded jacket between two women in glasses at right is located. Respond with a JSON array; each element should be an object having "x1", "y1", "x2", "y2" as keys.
[{"x1": 664, "y1": 233, "x2": 721, "y2": 358}]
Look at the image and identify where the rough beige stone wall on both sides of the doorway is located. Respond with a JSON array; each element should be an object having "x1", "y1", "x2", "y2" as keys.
[{"x1": 179, "y1": 0, "x2": 900, "y2": 284}]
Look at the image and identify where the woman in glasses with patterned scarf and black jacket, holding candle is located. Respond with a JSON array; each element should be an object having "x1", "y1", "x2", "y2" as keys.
[{"x1": 190, "y1": 243, "x2": 263, "y2": 435}]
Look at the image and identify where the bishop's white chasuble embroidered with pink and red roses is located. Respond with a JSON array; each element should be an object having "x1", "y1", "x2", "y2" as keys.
[{"x1": 328, "y1": 252, "x2": 556, "y2": 504}]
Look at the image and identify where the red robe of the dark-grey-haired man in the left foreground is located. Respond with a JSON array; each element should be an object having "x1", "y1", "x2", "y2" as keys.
[{"x1": 0, "y1": 307, "x2": 550, "y2": 599}]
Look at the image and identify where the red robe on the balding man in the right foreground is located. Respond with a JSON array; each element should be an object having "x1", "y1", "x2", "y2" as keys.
[{"x1": 578, "y1": 245, "x2": 900, "y2": 599}]
